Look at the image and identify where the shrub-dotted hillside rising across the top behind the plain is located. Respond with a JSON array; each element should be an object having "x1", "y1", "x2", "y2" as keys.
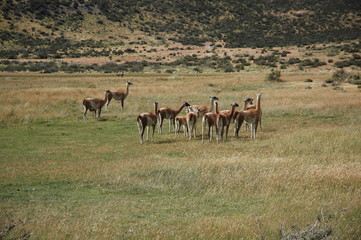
[{"x1": 0, "y1": 0, "x2": 361, "y2": 51}]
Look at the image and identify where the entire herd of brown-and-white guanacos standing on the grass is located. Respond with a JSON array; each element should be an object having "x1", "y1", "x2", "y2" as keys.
[{"x1": 83, "y1": 79, "x2": 262, "y2": 144}]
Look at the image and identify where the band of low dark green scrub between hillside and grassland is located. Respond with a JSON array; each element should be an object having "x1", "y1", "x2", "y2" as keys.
[{"x1": 0, "y1": 46, "x2": 361, "y2": 73}]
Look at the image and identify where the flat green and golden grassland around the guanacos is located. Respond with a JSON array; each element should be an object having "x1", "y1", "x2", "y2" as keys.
[{"x1": 0, "y1": 70, "x2": 361, "y2": 239}]
